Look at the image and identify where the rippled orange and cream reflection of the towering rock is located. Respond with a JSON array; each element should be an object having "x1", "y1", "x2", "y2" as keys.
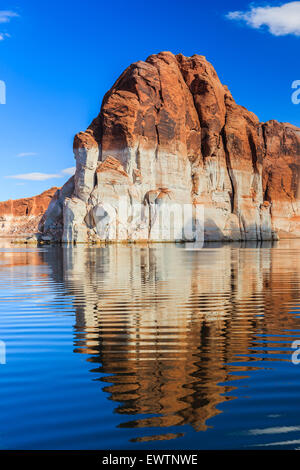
[{"x1": 43, "y1": 242, "x2": 300, "y2": 439}]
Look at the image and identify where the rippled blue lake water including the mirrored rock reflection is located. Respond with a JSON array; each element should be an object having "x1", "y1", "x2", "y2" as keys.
[{"x1": 0, "y1": 240, "x2": 300, "y2": 450}]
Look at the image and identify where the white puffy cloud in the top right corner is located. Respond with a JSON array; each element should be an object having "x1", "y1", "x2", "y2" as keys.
[{"x1": 226, "y1": 2, "x2": 300, "y2": 36}]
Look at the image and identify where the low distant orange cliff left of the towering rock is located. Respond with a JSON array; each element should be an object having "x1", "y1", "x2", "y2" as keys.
[{"x1": 0, "y1": 187, "x2": 58, "y2": 235}]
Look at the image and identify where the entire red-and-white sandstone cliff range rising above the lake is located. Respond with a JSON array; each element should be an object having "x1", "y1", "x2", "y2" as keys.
[{"x1": 0, "y1": 52, "x2": 300, "y2": 243}]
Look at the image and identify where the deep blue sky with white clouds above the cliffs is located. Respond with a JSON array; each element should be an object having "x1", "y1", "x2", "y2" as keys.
[{"x1": 0, "y1": 0, "x2": 300, "y2": 200}]
